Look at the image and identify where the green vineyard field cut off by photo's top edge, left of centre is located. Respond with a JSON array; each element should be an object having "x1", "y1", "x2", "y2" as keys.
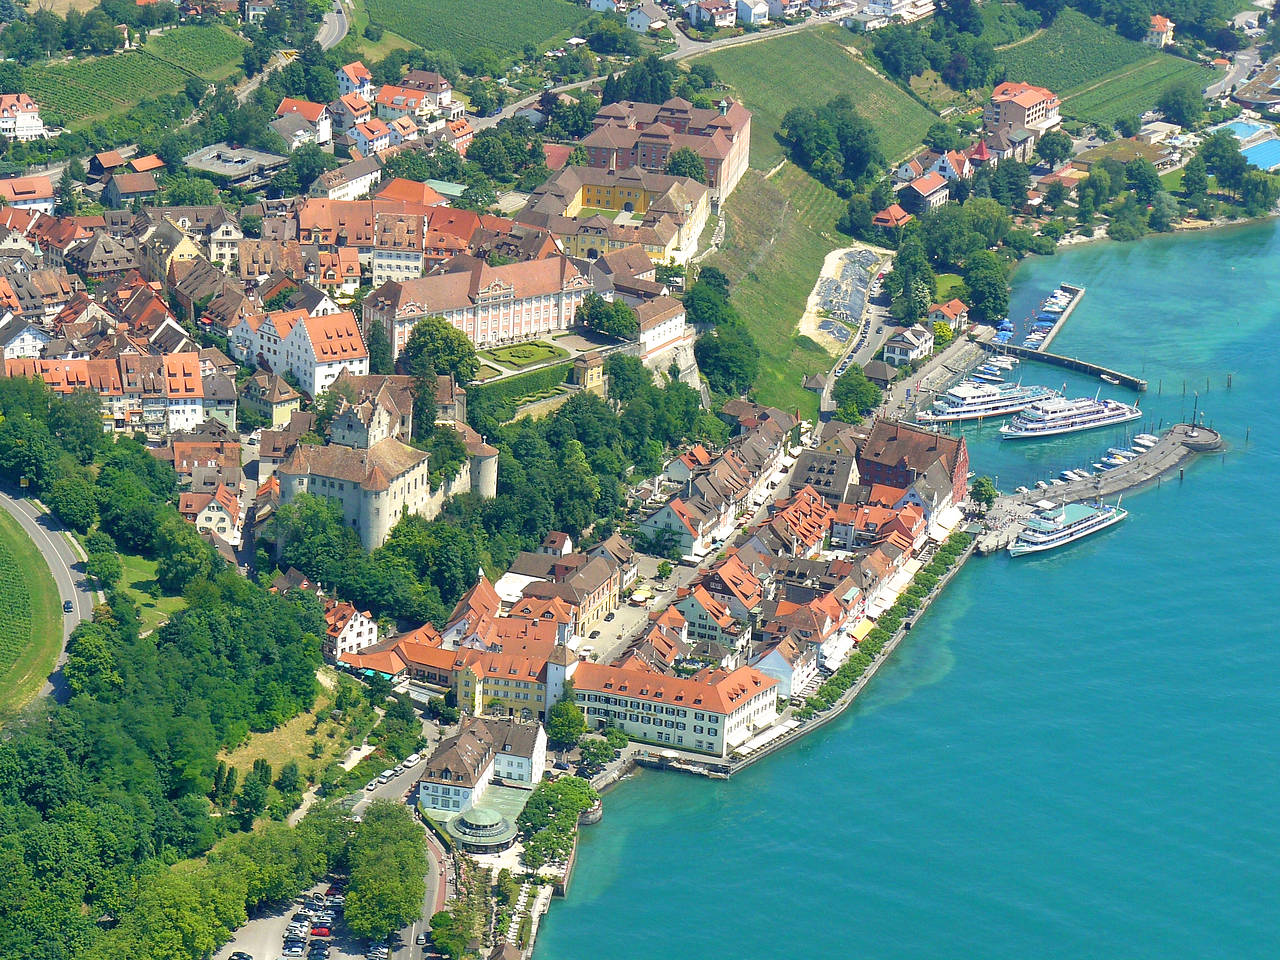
[{"x1": 367, "y1": 0, "x2": 591, "y2": 59}]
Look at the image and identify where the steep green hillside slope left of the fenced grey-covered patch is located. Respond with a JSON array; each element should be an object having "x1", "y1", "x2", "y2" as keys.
[{"x1": 708, "y1": 164, "x2": 847, "y2": 416}]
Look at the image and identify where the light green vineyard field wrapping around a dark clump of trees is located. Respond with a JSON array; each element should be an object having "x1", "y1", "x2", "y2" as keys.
[{"x1": 699, "y1": 26, "x2": 937, "y2": 170}]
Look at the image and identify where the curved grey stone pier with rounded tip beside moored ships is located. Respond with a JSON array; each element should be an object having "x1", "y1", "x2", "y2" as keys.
[{"x1": 978, "y1": 424, "x2": 1222, "y2": 553}]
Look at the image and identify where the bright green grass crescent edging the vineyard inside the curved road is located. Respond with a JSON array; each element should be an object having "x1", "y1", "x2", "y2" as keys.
[{"x1": 0, "y1": 511, "x2": 63, "y2": 712}]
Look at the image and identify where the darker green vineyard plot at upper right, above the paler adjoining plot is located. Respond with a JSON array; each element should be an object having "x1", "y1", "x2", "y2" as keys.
[{"x1": 997, "y1": 9, "x2": 1174, "y2": 97}]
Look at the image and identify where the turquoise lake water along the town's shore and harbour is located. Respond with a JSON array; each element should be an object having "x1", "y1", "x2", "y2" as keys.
[{"x1": 535, "y1": 224, "x2": 1280, "y2": 960}]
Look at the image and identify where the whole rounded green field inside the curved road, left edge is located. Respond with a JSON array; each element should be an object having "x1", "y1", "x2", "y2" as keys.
[{"x1": 0, "y1": 511, "x2": 63, "y2": 713}]
